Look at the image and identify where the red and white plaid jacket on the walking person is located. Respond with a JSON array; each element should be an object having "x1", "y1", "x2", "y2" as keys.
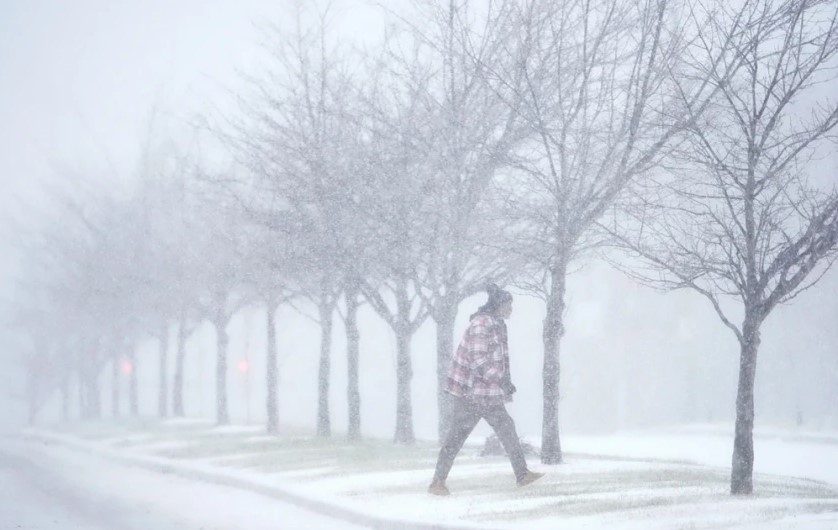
[{"x1": 445, "y1": 314, "x2": 512, "y2": 404}]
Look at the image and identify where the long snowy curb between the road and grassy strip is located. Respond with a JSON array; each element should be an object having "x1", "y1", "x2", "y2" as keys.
[{"x1": 22, "y1": 429, "x2": 492, "y2": 530}]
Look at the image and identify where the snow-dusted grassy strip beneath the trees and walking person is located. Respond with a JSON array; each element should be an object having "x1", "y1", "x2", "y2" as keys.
[{"x1": 18, "y1": 422, "x2": 838, "y2": 529}]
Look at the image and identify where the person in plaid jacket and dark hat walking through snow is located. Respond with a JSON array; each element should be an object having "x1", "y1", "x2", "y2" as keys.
[{"x1": 428, "y1": 284, "x2": 544, "y2": 495}]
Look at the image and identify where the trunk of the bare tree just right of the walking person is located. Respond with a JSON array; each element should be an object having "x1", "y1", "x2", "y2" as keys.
[{"x1": 541, "y1": 258, "x2": 567, "y2": 464}]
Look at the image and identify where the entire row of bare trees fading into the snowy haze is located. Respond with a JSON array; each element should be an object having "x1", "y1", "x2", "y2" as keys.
[{"x1": 9, "y1": 0, "x2": 838, "y2": 494}]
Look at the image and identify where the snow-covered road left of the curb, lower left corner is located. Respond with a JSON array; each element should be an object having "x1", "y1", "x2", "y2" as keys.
[{"x1": 0, "y1": 438, "x2": 360, "y2": 530}]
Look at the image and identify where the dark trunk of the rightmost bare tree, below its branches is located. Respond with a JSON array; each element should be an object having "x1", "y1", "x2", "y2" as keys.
[{"x1": 730, "y1": 316, "x2": 760, "y2": 495}]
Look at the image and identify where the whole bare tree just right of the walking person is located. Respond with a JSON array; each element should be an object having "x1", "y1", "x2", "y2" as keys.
[{"x1": 488, "y1": 0, "x2": 768, "y2": 464}]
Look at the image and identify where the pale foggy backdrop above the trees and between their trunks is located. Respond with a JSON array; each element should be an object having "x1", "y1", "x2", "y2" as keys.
[{"x1": 0, "y1": 0, "x2": 838, "y2": 438}]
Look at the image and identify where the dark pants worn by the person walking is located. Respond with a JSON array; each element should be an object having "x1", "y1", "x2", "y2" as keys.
[{"x1": 434, "y1": 398, "x2": 527, "y2": 482}]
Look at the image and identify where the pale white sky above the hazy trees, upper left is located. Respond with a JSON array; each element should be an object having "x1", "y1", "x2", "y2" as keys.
[{"x1": 0, "y1": 0, "x2": 403, "y2": 294}]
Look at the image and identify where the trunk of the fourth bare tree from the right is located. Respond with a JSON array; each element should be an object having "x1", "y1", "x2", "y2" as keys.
[{"x1": 393, "y1": 282, "x2": 416, "y2": 444}]
